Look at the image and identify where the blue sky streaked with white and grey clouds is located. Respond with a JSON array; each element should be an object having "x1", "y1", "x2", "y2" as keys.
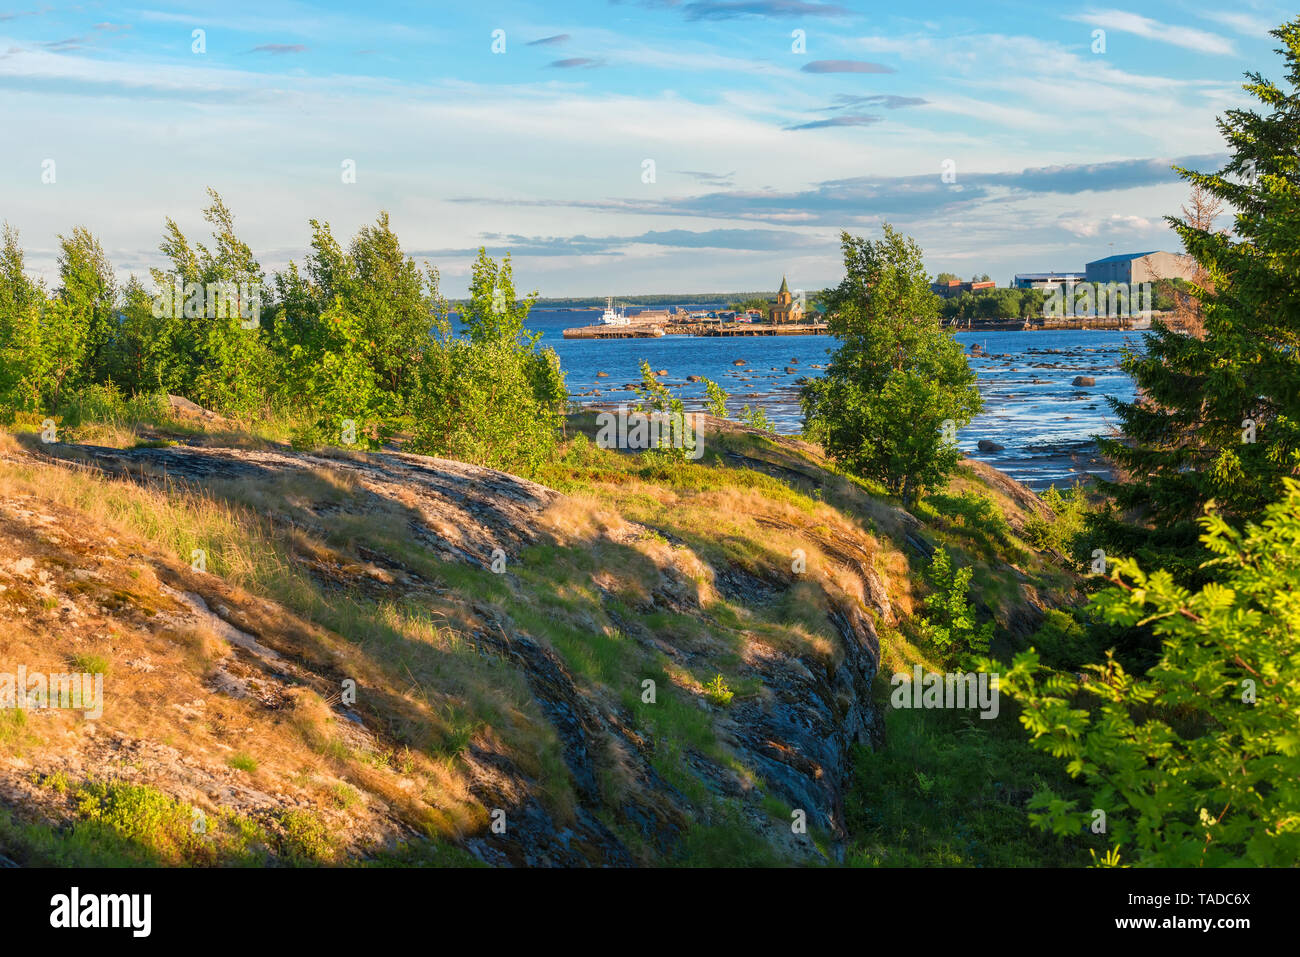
[{"x1": 0, "y1": 0, "x2": 1294, "y2": 296}]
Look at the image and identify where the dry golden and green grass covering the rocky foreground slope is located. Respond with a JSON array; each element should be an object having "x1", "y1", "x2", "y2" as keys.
[{"x1": 0, "y1": 416, "x2": 1097, "y2": 863}]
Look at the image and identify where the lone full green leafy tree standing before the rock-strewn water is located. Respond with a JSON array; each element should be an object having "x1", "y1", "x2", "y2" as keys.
[{"x1": 800, "y1": 224, "x2": 982, "y2": 506}]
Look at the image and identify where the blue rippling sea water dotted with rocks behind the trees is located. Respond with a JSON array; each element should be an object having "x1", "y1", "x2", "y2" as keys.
[{"x1": 506, "y1": 309, "x2": 1141, "y2": 489}]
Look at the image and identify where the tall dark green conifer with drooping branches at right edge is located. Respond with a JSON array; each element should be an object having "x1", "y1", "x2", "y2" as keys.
[{"x1": 1093, "y1": 17, "x2": 1300, "y2": 584}]
